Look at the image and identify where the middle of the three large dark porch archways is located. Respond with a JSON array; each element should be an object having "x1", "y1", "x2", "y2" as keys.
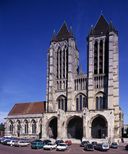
[{"x1": 67, "y1": 116, "x2": 83, "y2": 139}]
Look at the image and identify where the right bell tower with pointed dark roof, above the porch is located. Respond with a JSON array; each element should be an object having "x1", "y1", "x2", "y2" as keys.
[{"x1": 88, "y1": 15, "x2": 119, "y2": 110}]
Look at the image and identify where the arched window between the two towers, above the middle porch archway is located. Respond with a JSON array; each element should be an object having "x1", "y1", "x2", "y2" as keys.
[{"x1": 76, "y1": 94, "x2": 88, "y2": 111}]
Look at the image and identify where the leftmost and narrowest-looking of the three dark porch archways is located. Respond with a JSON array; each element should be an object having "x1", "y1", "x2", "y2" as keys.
[{"x1": 47, "y1": 117, "x2": 57, "y2": 139}]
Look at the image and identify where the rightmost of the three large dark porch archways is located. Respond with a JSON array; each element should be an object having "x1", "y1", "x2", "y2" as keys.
[{"x1": 91, "y1": 116, "x2": 108, "y2": 139}]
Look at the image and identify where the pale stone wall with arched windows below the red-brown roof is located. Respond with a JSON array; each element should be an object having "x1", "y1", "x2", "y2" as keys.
[{"x1": 5, "y1": 114, "x2": 42, "y2": 138}]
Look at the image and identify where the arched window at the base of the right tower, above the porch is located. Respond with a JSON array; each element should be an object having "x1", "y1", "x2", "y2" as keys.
[{"x1": 96, "y1": 93, "x2": 107, "y2": 110}]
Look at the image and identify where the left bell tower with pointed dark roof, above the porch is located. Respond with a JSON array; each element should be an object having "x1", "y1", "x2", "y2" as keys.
[{"x1": 46, "y1": 22, "x2": 79, "y2": 112}]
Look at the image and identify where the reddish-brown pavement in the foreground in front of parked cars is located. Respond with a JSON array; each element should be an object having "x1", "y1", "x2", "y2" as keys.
[{"x1": 0, "y1": 144, "x2": 128, "y2": 154}]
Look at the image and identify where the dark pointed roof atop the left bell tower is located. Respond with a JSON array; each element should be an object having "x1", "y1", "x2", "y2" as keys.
[{"x1": 52, "y1": 22, "x2": 73, "y2": 41}]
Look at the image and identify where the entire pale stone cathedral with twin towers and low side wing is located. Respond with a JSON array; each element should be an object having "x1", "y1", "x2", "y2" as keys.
[{"x1": 5, "y1": 15, "x2": 123, "y2": 141}]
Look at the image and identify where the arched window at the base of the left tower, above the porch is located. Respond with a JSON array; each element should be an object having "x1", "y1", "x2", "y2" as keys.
[{"x1": 57, "y1": 96, "x2": 67, "y2": 111}]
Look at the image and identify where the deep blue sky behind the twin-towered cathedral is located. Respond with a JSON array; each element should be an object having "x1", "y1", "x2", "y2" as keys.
[{"x1": 0, "y1": 0, "x2": 128, "y2": 123}]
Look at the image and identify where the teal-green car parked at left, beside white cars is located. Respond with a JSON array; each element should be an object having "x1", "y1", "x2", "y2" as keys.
[{"x1": 31, "y1": 140, "x2": 44, "y2": 149}]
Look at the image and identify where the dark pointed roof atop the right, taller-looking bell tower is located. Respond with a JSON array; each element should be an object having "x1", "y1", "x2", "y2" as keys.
[{"x1": 90, "y1": 15, "x2": 118, "y2": 36}]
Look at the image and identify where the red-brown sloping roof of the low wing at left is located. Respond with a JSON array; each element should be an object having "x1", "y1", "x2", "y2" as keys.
[{"x1": 8, "y1": 102, "x2": 46, "y2": 116}]
